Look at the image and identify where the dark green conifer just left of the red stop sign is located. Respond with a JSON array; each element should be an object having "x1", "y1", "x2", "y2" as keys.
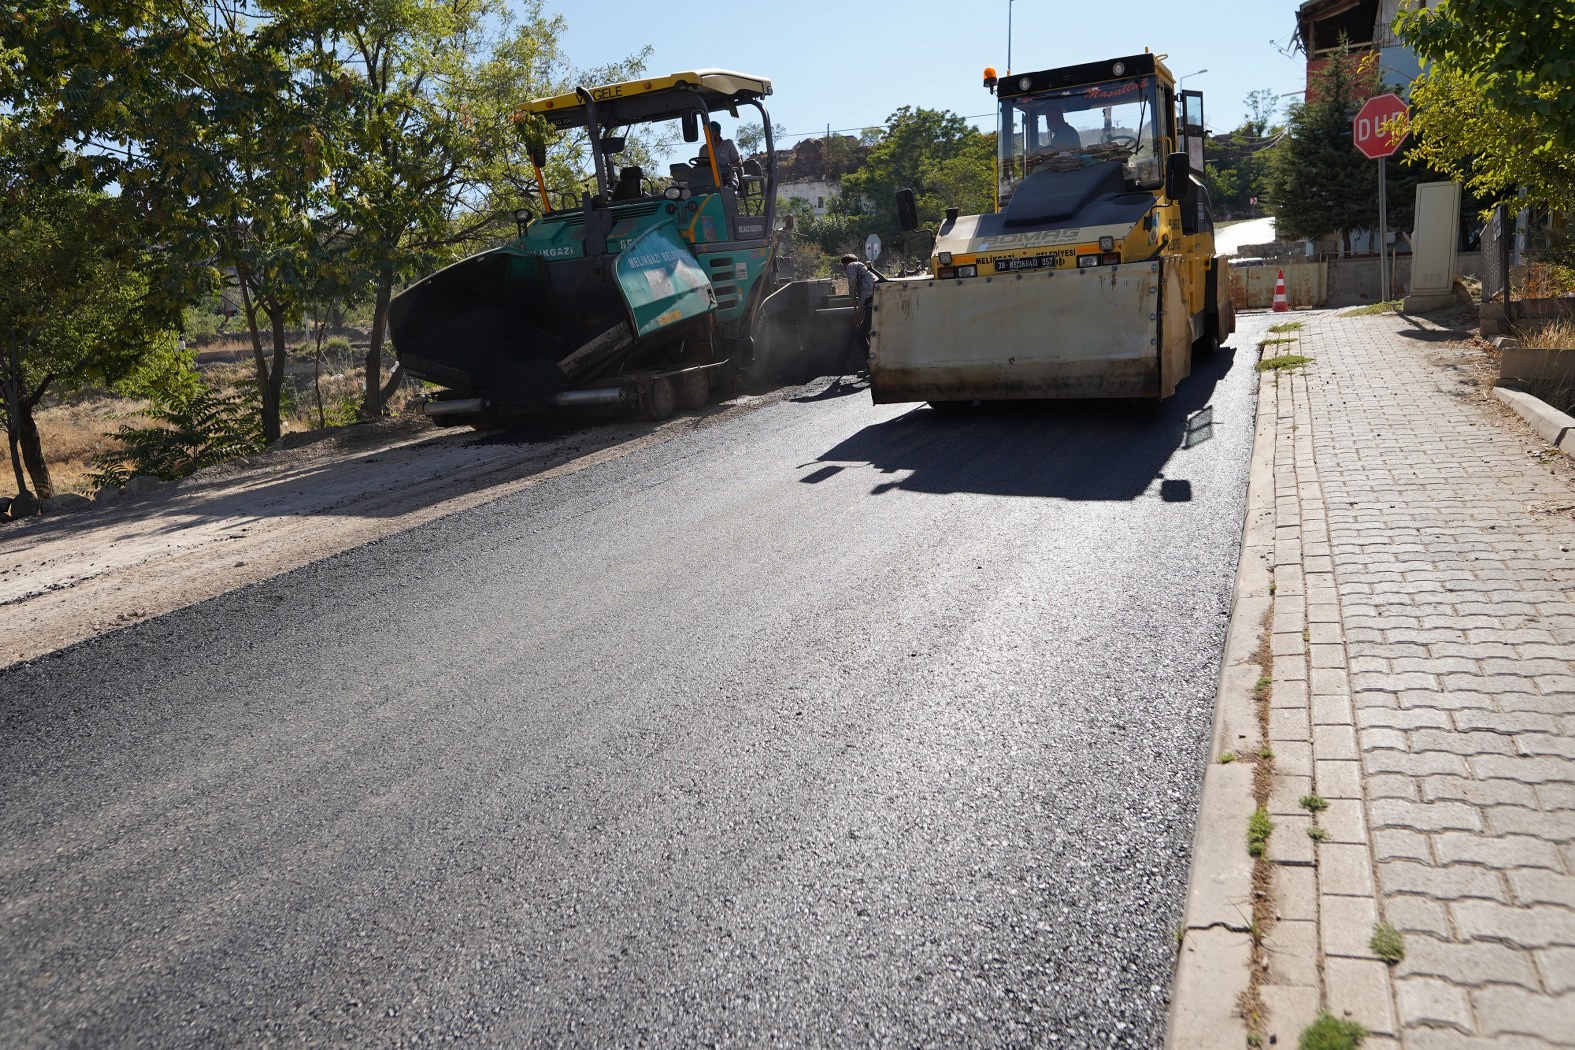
[{"x1": 1266, "y1": 50, "x2": 1381, "y2": 252}]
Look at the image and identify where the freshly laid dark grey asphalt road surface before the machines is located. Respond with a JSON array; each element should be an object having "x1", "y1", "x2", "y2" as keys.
[{"x1": 0, "y1": 316, "x2": 1266, "y2": 1047}]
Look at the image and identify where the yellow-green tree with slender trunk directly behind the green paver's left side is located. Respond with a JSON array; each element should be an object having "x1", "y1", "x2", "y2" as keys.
[{"x1": 326, "y1": 0, "x2": 649, "y2": 419}]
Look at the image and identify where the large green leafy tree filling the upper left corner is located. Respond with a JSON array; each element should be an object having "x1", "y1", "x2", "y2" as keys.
[{"x1": 0, "y1": 0, "x2": 343, "y2": 439}]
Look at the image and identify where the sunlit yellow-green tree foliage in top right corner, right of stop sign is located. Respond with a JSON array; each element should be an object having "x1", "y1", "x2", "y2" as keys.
[{"x1": 1394, "y1": 0, "x2": 1575, "y2": 208}]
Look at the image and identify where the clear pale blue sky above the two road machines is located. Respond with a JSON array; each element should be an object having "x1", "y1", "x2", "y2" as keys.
[{"x1": 543, "y1": 0, "x2": 1306, "y2": 145}]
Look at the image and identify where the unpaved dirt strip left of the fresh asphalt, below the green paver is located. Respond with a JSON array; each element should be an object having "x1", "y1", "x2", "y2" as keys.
[{"x1": 0, "y1": 392, "x2": 783, "y2": 667}]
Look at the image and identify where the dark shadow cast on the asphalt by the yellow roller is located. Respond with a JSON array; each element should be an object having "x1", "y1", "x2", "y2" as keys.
[{"x1": 802, "y1": 346, "x2": 1236, "y2": 502}]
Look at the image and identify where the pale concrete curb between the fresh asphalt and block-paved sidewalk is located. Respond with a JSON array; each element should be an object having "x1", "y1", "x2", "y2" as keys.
[{"x1": 1166, "y1": 376, "x2": 1276, "y2": 1050}]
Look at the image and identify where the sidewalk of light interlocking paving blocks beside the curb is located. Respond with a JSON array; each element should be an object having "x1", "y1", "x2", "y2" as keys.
[{"x1": 1260, "y1": 312, "x2": 1575, "y2": 1050}]
